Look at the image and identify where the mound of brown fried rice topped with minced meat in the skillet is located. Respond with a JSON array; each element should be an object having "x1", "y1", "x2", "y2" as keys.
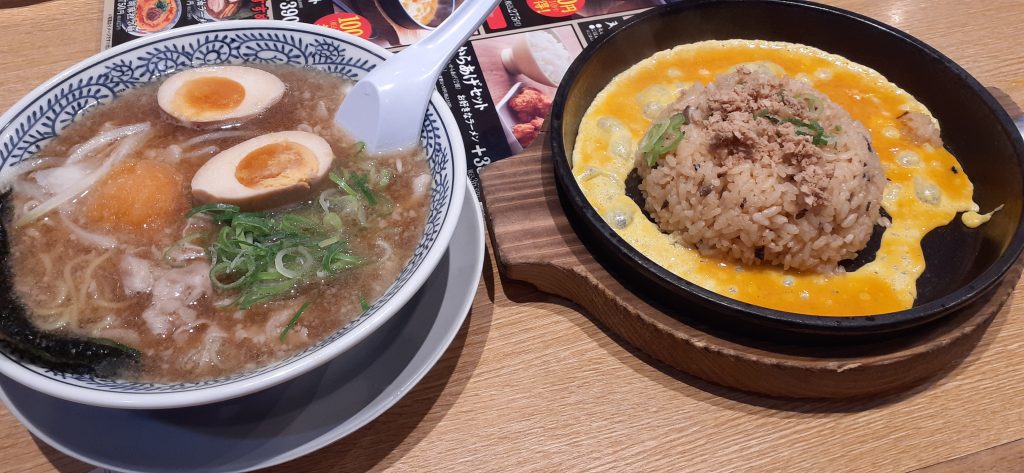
[{"x1": 636, "y1": 65, "x2": 885, "y2": 273}]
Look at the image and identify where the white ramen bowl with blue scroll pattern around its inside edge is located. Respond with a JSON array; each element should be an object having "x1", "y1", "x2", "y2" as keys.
[{"x1": 0, "y1": 20, "x2": 466, "y2": 409}]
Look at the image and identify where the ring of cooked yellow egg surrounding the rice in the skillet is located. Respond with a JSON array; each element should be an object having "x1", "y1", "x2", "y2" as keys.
[{"x1": 572, "y1": 40, "x2": 979, "y2": 316}]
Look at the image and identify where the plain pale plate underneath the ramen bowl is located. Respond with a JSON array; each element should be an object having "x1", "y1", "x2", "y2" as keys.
[{"x1": 0, "y1": 182, "x2": 483, "y2": 473}]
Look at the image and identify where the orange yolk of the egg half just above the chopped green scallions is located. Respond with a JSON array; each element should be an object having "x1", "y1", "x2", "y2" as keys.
[{"x1": 234, "y1": 141, "x2": 318, "y2": 188}]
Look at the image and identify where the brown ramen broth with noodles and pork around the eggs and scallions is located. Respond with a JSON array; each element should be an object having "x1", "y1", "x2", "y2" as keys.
[{"x1": 4, "y1": 67, "x2": 431, "y2": 382}]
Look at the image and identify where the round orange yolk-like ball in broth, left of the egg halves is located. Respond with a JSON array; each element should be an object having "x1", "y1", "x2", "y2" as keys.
[{"x1": 85, "y1": 160, "x2": 188, "y2": 234}]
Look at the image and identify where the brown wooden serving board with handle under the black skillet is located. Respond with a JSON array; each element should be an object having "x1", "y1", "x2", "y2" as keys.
[{"x1": 480, "y1": 135, "x2": 1024, "y2": 398}]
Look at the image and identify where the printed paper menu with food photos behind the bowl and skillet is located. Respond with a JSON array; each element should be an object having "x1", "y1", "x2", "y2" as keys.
[{"x1": 102, "y1": 0, "x2": 667, "y2": 192}]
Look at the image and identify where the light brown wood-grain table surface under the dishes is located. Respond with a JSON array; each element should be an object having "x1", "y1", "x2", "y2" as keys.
[{"x1": 0, "y1": 0, "x2": 1024, "y2": 472}]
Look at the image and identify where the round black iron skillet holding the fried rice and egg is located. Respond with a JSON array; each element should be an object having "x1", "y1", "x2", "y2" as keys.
[{"x1": 551, "y1": 0, "x2": 1024, "y2": 338}]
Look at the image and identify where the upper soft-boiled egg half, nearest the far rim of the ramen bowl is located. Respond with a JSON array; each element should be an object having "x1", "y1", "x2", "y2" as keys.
[{"x1": 157, "y1": 66, "x2": 285, "y2": 128}]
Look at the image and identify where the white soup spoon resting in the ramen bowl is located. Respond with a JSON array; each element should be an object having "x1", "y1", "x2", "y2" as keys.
[{"x1": 334, "y1": 0, "x2": 500, "y2": 153}]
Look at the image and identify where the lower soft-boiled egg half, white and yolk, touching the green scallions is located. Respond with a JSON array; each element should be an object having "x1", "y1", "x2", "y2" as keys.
[{"x1": 191, "y1": 131, "x2": 334, "y2": 210}]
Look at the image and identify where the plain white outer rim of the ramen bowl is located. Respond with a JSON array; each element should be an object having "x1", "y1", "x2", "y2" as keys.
[{"x1": 0, "y1": 19, "x2": 468, "y2": 410}]
